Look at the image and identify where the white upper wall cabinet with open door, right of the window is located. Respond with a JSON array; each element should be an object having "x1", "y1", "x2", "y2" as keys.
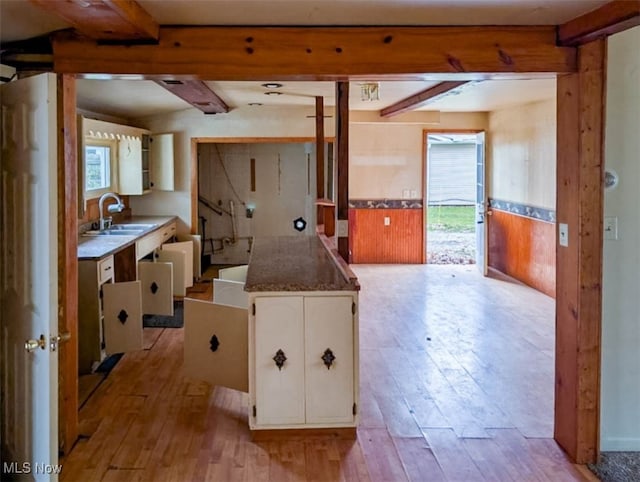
[{"x1": 118, "y1": 133, "x2": 174, "y2": 195}]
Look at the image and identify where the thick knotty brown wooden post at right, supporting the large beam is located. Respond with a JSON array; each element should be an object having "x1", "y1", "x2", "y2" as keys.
[{"x1": 554, "y1": 39, "x2": 606, "y2": 464}]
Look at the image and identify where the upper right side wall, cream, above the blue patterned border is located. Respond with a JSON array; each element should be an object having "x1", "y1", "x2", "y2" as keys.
[{"x1": 487, "y1": 97, "x2": 556, "y2": 210}]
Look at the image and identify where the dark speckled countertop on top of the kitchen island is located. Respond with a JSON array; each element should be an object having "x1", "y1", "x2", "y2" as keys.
[{"x1": 244, "y1": 236, "x2": 360, "y2": 292}]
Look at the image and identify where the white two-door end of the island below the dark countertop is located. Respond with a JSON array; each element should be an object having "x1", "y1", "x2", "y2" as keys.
[{"x1": 249, "y1": 292, "x2": 358, "y2": 429}]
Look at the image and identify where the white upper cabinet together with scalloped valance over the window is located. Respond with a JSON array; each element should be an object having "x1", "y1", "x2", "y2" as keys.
[{"x1": 81, "y1": 118, "x2": 174, "y2": 195}]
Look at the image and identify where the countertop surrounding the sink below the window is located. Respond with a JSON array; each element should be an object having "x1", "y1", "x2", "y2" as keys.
[{"x1": 78, "y1": 216, "x2": 178, "y2": 261}]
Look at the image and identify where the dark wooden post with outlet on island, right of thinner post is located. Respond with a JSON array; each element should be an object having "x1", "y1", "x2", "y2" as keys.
[{"x1": 335, "y1": 82, "x2": 351, "y2": 263}]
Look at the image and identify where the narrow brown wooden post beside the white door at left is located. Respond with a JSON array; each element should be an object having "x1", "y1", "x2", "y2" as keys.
[{"x1": 57, "y1": 74, "x2": 78, "y2": 454}]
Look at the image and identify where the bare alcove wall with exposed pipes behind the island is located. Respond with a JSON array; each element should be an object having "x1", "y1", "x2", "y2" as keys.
[{"x1": 198, "y1": 142, "x2": 316, "y2": 264}]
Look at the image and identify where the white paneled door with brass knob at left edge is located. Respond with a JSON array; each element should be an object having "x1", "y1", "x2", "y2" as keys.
[{"x1": 0, "y1": 74, "x2": 58, "y2": 480}]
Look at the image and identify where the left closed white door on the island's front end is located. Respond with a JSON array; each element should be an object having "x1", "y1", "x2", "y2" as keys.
[{"x1": 255, "y1": 296, "x2": 305, "y2": 426}]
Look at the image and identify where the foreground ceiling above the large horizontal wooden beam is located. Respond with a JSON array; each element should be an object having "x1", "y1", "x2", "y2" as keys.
[{"x1": 0, "y1": 0, "x2": 609, "y2": 42}]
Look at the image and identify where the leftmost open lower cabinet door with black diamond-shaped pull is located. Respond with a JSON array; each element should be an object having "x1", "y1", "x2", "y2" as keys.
[{"x1": 102, "y1": 281, "x2": 142, "y2": 355}]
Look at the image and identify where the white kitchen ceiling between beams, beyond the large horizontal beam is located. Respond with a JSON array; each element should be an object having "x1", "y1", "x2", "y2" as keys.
[{"x1": 78, "y1": 78, "x2": 556, "y2": 119}]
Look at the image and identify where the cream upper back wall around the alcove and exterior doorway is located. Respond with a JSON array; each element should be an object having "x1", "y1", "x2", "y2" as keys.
[{"x1": 130, "y1": 106, "x2": 487, "y2": 232}]
